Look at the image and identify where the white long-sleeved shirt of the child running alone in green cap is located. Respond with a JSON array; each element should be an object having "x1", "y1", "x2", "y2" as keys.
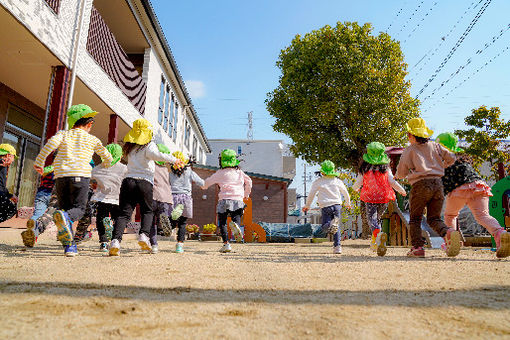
[{"x1": 305, "y1": 176, "x2": 351, "y2": 209}]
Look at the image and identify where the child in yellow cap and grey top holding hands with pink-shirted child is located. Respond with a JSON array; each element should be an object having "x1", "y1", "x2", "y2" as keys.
[{"x1": 170, "y1": 151, "x2": 205, "y2": 253}]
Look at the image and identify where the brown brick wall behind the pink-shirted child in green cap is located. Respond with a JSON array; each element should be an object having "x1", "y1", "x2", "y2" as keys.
[{"x1": 188, "y1": 168, "x2": 287, "y2": 226}]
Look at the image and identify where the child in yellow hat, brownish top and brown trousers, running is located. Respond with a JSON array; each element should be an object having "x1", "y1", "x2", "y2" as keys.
[{"x1": 395, "y1": 118, "x2": 460, "y2": 257}]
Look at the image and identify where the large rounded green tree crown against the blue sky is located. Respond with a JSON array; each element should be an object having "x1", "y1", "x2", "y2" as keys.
[{"x1": 266, "y1": 22, "x2": 419, "y2": 170}]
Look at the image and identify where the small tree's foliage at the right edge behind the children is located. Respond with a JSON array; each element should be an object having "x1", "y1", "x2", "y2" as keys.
[{"x1": 455, "y1": 106, "x2": 510, "y2": 179}]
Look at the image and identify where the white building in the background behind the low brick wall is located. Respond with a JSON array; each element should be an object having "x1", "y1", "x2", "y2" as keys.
[{"x1": 206, "y1": 139, "x2": 296, "y2": 179}]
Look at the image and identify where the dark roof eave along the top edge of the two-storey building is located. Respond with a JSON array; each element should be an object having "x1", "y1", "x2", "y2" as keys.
[{"x1": 141, "y1": 0, "x2": 211, "y2": 153}]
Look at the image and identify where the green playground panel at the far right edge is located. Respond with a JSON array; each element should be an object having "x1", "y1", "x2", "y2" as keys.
[{"x1": 489, "y1": 176, "x2": 510, "y2": 250}]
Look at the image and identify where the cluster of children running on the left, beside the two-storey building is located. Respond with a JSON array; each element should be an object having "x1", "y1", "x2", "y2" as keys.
[{"x1": 0, "y1": 104, "x2": 252, "y2": 256}]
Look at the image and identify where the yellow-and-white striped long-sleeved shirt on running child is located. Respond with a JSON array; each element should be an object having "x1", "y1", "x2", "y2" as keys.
[{"x1": 34, "y1": 128, "x2": 113, "y2": 178}]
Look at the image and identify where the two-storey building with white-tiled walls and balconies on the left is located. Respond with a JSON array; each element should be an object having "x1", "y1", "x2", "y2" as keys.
[{"x1": 0, "y1": 0, "x2": 210, "y2": 207}]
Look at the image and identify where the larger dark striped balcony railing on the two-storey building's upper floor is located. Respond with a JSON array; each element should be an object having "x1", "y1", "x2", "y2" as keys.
[{"x1": 87, "y1": 8, "x2": 147, "y2": 115}]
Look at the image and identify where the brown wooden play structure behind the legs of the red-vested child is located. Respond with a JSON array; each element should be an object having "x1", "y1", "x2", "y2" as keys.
[{"x1": 382, "y1": 201, "x2": 432, "y2": 248}]
